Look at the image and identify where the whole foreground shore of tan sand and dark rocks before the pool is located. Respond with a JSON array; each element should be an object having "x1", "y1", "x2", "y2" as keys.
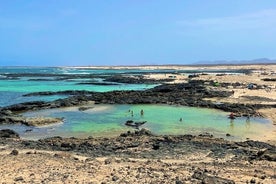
[{"x1": 0, "y1": 129, "x2": 276, "y2": 184}]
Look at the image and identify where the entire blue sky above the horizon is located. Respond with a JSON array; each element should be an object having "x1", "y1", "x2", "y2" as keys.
[{"x1": 0, "y1": 0, "x2": 276, "y2": 66}]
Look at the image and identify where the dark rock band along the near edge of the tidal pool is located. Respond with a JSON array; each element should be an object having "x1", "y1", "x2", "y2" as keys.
[{"x1": 0, "y1": 129, "x2": 276, "y2": 162}]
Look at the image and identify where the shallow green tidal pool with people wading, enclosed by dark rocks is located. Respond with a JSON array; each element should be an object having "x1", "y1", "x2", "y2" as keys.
[{"x1": 3, "y1": 105, "x2": 276, "y2": 140}]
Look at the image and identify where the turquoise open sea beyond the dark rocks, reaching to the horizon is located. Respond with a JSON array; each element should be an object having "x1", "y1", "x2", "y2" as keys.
[{"x1": 0, "y1": 67, "x2": 246, "y2": 107}]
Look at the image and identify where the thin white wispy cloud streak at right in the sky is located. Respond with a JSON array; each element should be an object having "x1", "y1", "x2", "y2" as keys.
[{"x1": 177, "y1": 9, "x2": 276, "y2": 30}]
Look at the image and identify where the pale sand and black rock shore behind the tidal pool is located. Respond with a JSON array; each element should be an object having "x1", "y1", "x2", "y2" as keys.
[{"x1": 1, "y1": 65, "x2": 276, "y2": 141}]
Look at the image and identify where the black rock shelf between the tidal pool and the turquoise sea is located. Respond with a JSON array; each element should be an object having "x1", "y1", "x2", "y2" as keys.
[{"x1": 0, "y1": 80, "x2": 276, "y2": 124}]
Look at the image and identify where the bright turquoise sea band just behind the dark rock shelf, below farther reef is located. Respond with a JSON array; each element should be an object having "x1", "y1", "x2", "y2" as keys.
[{"x1": 0, "y1": 79, "x2": 156, "y2": 107}]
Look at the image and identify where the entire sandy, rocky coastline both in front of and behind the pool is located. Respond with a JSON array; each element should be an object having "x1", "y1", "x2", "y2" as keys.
[{"x1": 0, "y1": 65, "x2": 276, "y2": 184}]
